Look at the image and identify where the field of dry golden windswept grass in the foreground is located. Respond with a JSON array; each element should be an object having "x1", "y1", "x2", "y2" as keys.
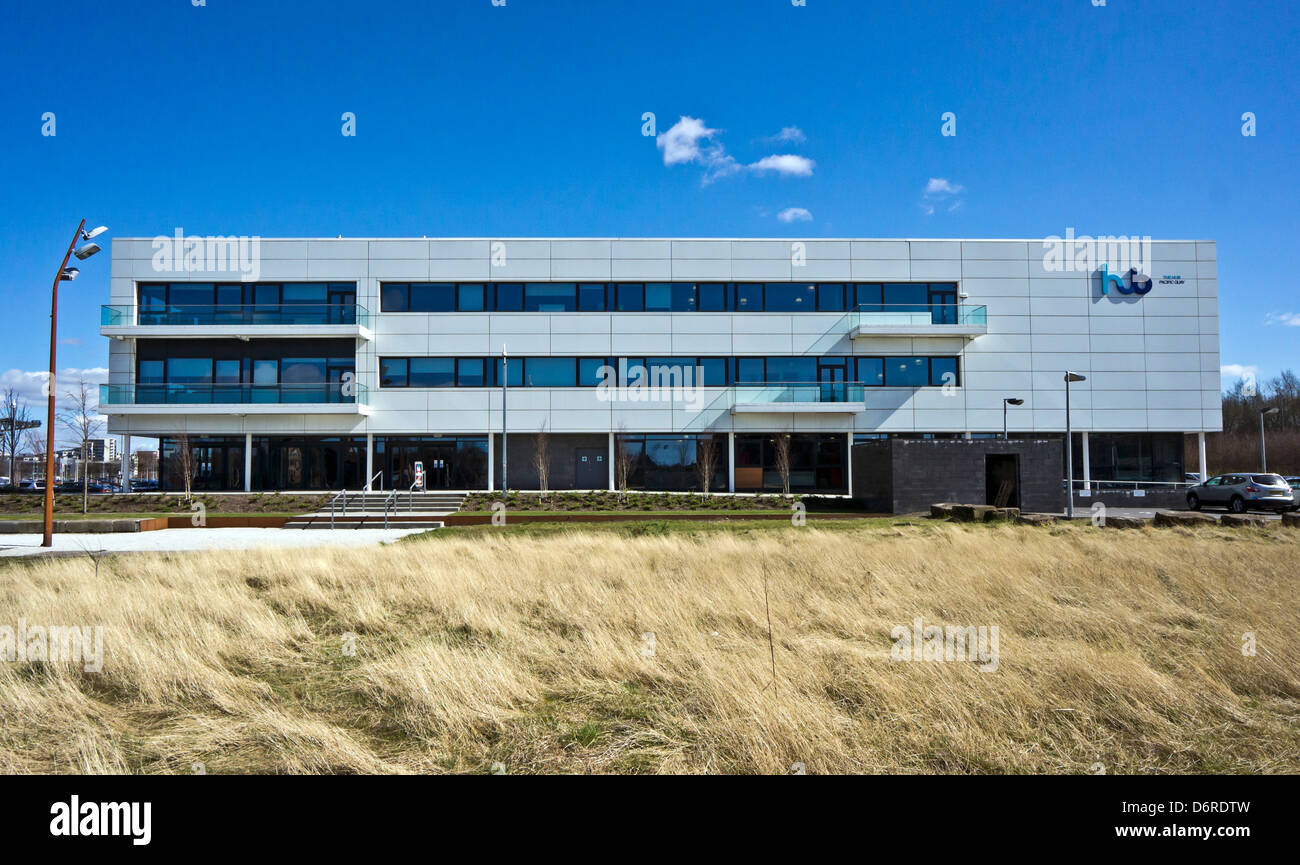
[{"x1": 0, "y1": 523, "x2": 1300, "y2": 774}]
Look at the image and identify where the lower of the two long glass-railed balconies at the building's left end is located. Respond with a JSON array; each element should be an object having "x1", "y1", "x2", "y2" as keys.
[{"x1": 99, "y1": 381, "x2": 371, "y2": 415}]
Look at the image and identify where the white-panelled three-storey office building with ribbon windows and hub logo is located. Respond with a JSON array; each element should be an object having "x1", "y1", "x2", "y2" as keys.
[{"x1": 100, "y1": 238, "x2": 1222, "y2": 494}]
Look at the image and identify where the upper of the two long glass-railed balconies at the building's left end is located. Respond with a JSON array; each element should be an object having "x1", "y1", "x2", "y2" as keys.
[{"x1": 99, "y1": 303, "x2": 373, "y2": 339}]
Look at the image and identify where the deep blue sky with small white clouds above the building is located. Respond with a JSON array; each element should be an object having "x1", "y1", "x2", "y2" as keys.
[{"x1": 0, "y1": 0, "x2": 1300, "y2": 442}]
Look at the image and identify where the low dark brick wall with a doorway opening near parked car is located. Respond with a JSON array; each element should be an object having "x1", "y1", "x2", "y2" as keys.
[{"x1": 853, "y1": 438, "x2": 1065, "y2": 514}]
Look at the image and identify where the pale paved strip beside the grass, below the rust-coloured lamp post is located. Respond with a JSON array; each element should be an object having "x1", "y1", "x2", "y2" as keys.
[{"x1": 0, "y1": 528, "x2": 425, "y2": 557}]
